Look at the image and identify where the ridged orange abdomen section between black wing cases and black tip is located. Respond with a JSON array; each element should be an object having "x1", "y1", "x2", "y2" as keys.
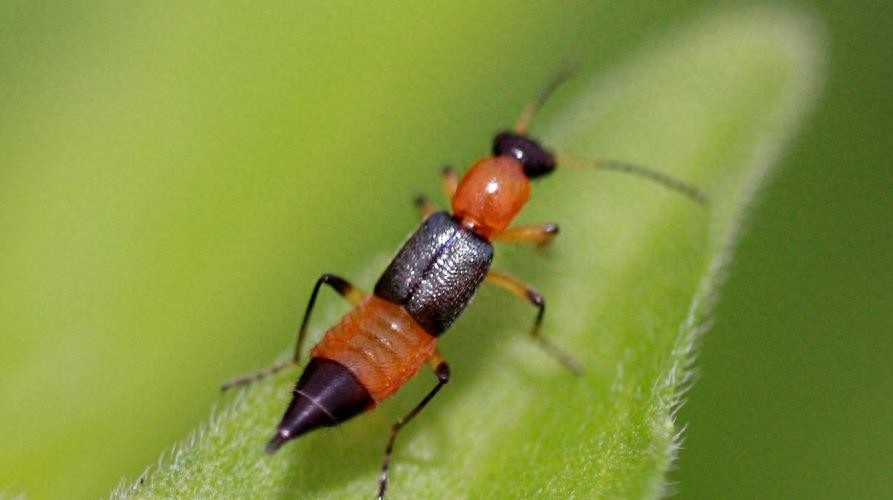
[{"x1": 311, "y1": 295, "x2": 436, "y2": 403}]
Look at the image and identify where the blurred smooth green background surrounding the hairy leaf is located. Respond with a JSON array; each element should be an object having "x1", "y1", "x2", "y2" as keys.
[{"x1": 0, "y1": 1, "x2": 893, "y2": 498}]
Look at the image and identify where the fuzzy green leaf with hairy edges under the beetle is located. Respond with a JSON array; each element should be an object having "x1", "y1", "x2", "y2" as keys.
[{"x1": 114, "y1": 9, "x2": 822, "y2": 498}]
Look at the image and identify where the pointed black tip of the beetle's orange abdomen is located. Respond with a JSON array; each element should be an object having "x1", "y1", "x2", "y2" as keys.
[{"x1": 266, "y1": 358, "x2": 373, "y2": 453}]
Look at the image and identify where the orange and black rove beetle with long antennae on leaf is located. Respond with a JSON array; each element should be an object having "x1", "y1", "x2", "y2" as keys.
[{"x1": 223, "y1": 71, "x2": 707, "y2": 499}]
